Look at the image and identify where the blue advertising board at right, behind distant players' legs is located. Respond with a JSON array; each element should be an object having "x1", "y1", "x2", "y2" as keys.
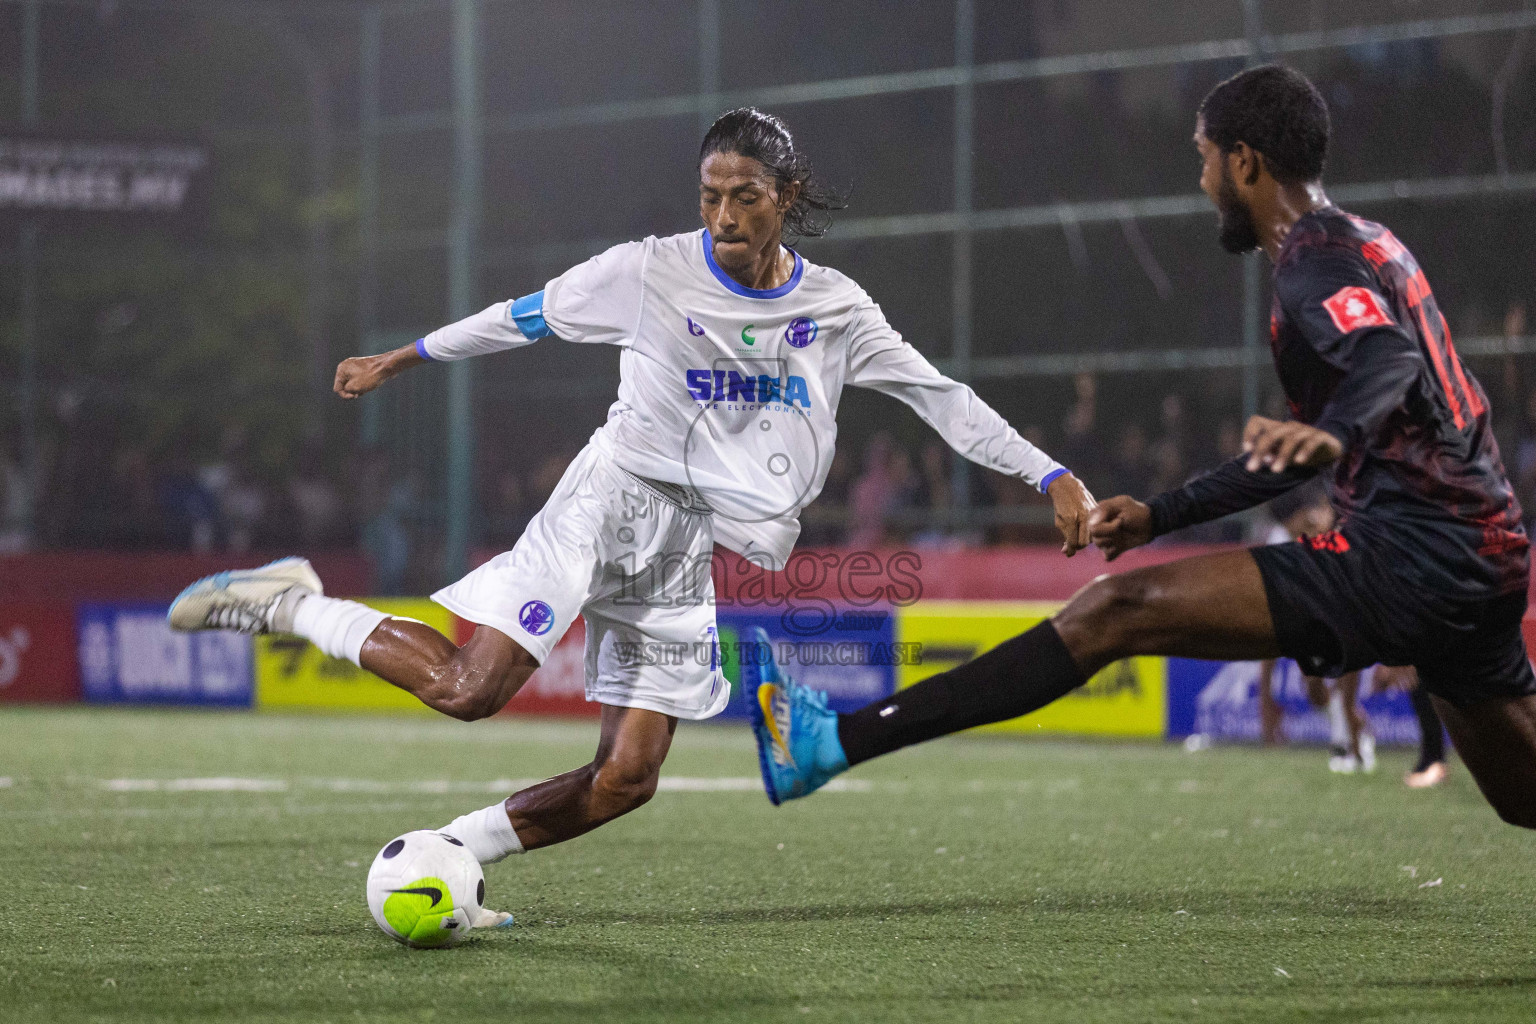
[{"x1": 1167, "y1": 657, "x2": 1419, "y2": 745}]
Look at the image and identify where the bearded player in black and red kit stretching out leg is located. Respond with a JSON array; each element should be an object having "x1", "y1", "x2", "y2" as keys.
[{"x1": 745, "y1": 66, "x2": 1536, "y2": 827}]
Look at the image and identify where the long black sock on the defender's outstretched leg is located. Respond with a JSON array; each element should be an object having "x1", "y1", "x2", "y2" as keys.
[{"x1": 837, "y1": 620, "x2": 1086, "y2": 765}]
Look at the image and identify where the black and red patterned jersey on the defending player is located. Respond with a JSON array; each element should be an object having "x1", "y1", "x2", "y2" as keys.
[{"x1": 1270, "y1": 207, "x2": 1530, "y2": 597}]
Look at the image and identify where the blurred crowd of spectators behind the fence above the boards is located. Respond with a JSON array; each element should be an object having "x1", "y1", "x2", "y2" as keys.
[{"x1": 0, "y1": 304, "x2": 1536, "y2": 590}]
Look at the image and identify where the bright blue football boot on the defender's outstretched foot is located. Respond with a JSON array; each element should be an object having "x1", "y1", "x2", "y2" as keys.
[{"x1": 742, "y1": 629, "x2": 848, "y2": 806}]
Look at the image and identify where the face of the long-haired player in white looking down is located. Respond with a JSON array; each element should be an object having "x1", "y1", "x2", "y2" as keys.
[{"x1": 699, "y1": 154, "x2": 790, "y2": 272}]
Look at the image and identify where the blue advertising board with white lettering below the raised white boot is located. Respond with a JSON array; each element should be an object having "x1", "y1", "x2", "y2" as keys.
[{"x1": 75, "y1": 603, "x2": 253, "y2": 708}]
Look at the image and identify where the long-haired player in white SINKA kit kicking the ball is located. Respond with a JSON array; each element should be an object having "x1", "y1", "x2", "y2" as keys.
[{"x1": 170, "y1": 109, "x2": 1094, "y2": 902}]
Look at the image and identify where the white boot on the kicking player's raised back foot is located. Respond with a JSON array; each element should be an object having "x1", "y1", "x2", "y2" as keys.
[{"x1": 166, "y1": 557, "x2": 326, "y2": 633}]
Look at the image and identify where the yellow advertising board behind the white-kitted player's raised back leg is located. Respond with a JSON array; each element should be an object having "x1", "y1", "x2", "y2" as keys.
[{"x1": 255, "y1": 597, "x2": 453, "y2": 712}]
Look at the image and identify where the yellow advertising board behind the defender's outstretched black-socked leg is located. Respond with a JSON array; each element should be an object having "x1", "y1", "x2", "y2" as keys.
[{"x1": 895, "y1": 600, "x2": 1167, "y2": 737}]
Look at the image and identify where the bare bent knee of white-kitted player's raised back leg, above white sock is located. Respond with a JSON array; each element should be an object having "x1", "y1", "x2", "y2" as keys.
[{"x1": 359, "y1": 619, "x2": 539, "y2": 722}]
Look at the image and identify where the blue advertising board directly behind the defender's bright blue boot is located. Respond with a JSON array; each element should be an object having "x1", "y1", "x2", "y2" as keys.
[{"x1": 716, "y1": 606, "x2": 900, "y2": 718}]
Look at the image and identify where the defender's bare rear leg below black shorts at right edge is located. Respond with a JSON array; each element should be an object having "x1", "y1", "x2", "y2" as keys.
[{"x1": 1432, "y1": 697, "x2": 1536, "y2": 829}]
